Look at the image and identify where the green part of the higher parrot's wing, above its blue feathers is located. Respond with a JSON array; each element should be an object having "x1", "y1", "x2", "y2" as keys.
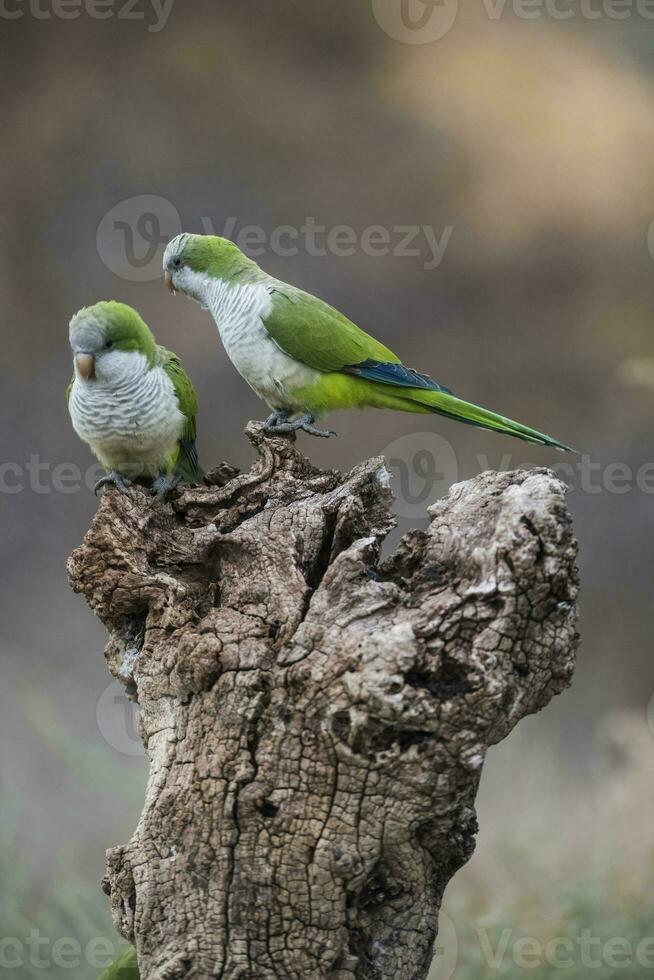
[{"x1": 263, "y1": 284, "x2": 400, "y2": 372}]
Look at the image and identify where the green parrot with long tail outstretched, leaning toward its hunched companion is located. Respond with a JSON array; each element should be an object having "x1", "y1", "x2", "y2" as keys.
[{"x1": 164, "y1": 234, "x2": 574, "y2": 452}]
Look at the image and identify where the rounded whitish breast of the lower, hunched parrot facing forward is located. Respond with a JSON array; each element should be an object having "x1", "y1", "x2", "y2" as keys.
[{"x1": 69, "y1": 353, "x2": 185, "y2": 476}]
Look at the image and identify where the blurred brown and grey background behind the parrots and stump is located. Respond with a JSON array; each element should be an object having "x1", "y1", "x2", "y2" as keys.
[{"x1": 0, "y1": 0, "x2": 654, "y2": 978}]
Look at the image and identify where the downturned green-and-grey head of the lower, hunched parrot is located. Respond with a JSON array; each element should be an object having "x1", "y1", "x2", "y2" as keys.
[{"x1": 69, "y1": 302, "x2": 157, "y2": 384}]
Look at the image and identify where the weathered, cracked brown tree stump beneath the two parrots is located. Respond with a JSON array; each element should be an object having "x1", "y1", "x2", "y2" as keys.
[{"x1": 69, "y1": 424, "x2": 577, "y2": 980}]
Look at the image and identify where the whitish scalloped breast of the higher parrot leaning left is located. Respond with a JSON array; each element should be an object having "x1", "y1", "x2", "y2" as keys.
[{"x1": 187, "y1": 272, "x2": 320, "y2": 411}]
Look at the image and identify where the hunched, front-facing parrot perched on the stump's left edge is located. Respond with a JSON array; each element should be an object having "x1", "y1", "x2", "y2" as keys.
[{"x1": 66, "y1": 302, "x2": 203, "y2": 499}]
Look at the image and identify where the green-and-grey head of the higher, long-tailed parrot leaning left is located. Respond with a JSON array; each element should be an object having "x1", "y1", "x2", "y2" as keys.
[{"x1": 163, "y1": 234, "x2": 258, "y2": 304}]
